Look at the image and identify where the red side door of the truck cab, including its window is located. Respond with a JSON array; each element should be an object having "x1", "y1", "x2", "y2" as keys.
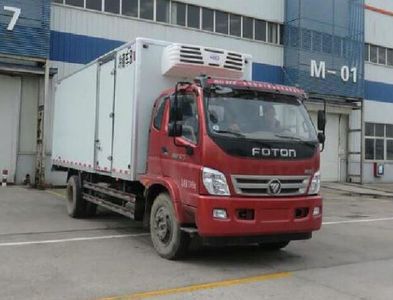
[{"x1": 160, "y1": 93, "x2": 202, "y2": 207}]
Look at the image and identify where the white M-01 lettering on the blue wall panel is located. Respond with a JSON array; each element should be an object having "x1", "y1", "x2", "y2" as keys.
[{"x1": 310, "y1": 60, "x2": 358, "y2": 83}]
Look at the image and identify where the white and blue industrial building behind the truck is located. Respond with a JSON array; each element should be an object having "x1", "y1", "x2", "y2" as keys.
[{"x1": 0, "y1": 0, "x2": 393, "y2": 184}]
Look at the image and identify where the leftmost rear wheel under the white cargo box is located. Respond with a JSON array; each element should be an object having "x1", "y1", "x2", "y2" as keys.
[{"x1": 66, "y1": 175, "x2": 87, "y2": 219}]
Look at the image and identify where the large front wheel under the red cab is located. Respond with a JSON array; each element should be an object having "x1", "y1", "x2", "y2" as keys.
[{"x1": 150, "y1": 193, "x2": 190, "y2": 260}]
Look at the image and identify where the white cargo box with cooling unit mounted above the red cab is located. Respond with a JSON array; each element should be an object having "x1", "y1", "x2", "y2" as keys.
[{"x1": 52, "y1": 38, "x2": 252, "y2": 180}]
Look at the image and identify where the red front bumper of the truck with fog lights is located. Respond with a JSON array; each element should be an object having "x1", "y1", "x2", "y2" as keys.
[{"x1": 195, "y1": 195, "x2": 322, "y2": 237}]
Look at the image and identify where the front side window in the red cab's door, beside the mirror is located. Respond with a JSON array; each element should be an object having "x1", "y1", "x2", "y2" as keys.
[{"x1": 179, "y1": 94, "x2": 199, "y2": 144}]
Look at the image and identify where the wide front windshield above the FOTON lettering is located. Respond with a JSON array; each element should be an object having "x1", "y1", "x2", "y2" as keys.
[{"x1": 205, "y1": 90, "x2": 317, "y2": 142}]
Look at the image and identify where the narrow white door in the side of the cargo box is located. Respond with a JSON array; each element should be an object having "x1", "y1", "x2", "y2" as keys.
[{"x1": 95, "y1": 57, "x2": 115, "y2": 172}]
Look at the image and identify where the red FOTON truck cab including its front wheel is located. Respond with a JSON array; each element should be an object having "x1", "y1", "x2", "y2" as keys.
[{"x1": 141, "y1": 78, "x2": 322, "y2": 258}]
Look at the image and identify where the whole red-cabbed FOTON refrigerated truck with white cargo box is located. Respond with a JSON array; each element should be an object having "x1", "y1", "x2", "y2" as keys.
[{"x1": 52, "y1": 38, "x2": 324, "y2": 259}]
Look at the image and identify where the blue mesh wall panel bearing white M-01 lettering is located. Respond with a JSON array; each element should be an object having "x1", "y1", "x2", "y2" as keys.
[{"x1": 284, "y1": 0, "x2": 364, "y2": 98}]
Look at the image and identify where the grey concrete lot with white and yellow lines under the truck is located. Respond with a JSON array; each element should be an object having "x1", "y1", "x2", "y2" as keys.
[{"x1": 0, "y1": 186, "x2": 393, "y2": 300}]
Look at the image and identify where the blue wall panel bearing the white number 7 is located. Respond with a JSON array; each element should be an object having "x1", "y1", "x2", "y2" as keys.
[{"x1": 0, "y1": 0, "x2": 50, "y2": 59}]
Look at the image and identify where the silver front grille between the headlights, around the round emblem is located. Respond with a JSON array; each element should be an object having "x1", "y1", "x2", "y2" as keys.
[{"x1": 231, "y1": 175, "x2": 309, "y2": 197}]
